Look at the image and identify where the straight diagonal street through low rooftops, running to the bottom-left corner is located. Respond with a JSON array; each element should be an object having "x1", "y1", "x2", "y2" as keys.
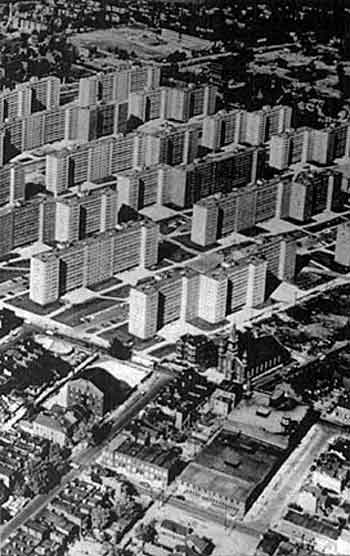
[{"x1": 0, "y1": 372, "x2": 171, "y2": 548}]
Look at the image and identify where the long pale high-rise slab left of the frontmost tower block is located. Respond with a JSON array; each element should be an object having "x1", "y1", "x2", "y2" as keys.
[{"x1": 29, "y1": 221, "x2": 158, "y2": 305}]
